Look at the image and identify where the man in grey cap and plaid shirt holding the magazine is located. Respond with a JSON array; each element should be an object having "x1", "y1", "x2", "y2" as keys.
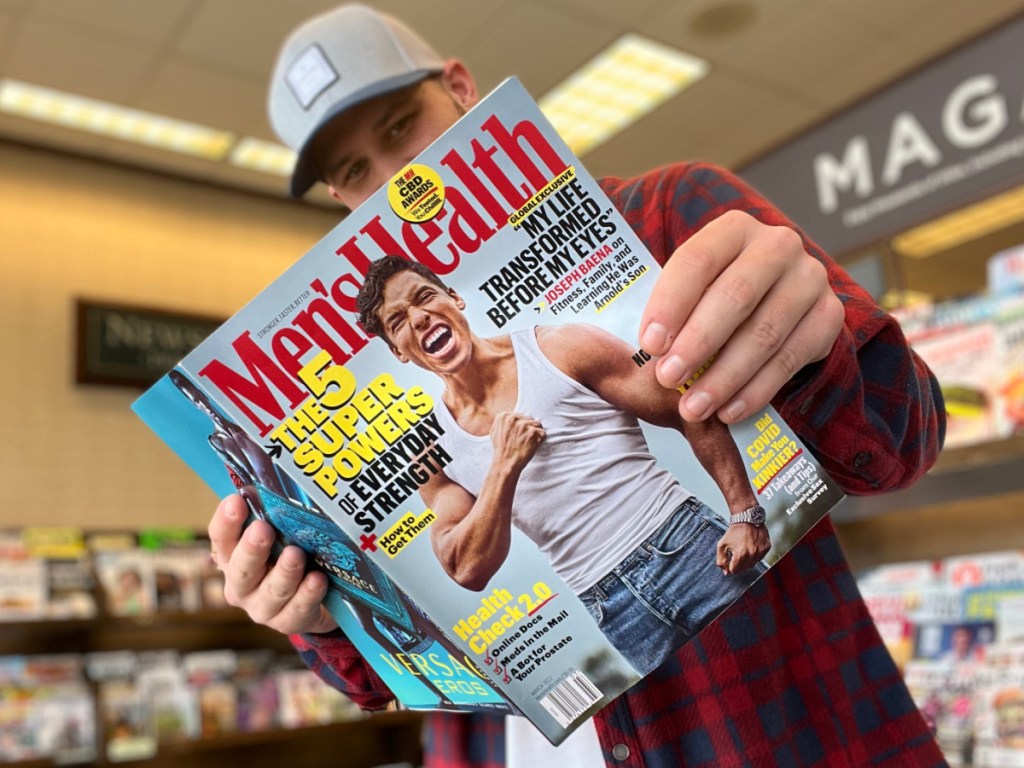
[{"x1": 210, "y1": 6, "x2": 944, "y2": 768}]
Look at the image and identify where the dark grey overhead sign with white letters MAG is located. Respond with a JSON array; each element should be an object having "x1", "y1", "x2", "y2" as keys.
[{"x1": 740, "y1": 17, "x2": 1024, "y2": 256}]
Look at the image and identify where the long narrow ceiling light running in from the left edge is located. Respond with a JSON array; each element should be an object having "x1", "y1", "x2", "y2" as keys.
[{"x1": 0, "y1": 80, "x2": 234, "y2": 160}]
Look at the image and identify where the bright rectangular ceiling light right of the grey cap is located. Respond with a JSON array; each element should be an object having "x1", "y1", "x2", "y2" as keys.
[{"x1": 540, "y1": 35, "x2": 710, "y2": 155}]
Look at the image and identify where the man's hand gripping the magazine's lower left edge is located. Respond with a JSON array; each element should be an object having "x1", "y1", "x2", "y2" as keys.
[{"x1": 208, "y1": 495, "x2": 338, "y2": 635}]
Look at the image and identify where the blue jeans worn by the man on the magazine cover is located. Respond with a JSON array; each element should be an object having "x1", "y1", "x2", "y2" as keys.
[{"x1": 580, "y1": 497, "x2": 767, "y2": 675}]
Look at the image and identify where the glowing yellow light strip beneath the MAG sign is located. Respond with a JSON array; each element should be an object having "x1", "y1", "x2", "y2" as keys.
[{"x1": 892, "y1": 186, "x2": 1024, "y2": 259}]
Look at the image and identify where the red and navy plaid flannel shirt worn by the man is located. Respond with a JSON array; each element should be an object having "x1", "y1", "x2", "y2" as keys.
[{"x1": 293, "y1": 164, "x2": 945, "y2": 768}]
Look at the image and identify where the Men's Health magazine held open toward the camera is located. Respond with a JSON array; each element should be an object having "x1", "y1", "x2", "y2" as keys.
[{"x1": 134, "y1": 79, "x2": 842, "y2": 743}]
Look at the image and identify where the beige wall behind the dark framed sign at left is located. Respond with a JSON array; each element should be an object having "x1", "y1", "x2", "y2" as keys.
[{"x1": 0, "y1": 143, "x2": 337, "y2": 529}]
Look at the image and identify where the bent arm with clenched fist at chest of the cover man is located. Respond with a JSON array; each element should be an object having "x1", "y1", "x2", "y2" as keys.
[{"x1": 420, "y1": 412, "x2": 545, "y2": 592}]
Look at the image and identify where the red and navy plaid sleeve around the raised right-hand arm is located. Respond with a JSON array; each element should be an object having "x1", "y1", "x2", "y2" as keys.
[{"x1": 602, "y1": 164, "x2": 945, "y2": 495}]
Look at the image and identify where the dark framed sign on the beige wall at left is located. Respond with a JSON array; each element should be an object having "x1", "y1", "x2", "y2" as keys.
[{"x1": 75, "y1": 299, "x2": 223, "y2": 387}]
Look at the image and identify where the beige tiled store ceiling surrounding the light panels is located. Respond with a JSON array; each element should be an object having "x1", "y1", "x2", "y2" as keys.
[{"x1": 6, "y1": 0, "x2": 1024, "y2": 214}]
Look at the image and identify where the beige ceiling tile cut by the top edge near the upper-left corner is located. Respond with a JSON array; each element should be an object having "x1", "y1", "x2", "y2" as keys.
[{"x1": 28, "y1": 0, "x2": 193, "y2": 45}]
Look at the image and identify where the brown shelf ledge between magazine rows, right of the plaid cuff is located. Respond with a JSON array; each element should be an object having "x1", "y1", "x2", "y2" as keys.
[{"x1": 833, "y1": 435, "x2": 1024, "y2": 569}]
